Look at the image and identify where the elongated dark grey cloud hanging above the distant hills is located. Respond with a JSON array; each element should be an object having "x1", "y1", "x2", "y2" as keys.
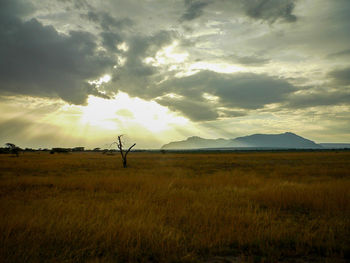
[{"x1": 164, "y1": 71, "x2": 295, "y2": 109}]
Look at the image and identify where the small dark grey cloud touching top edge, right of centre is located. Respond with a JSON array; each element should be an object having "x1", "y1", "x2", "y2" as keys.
[{"x1": 243, "y1": 0, "x2": 297, "y2": 23}]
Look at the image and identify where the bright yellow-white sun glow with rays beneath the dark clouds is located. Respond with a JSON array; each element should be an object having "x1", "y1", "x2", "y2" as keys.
[{"x1": 0, "y1": 92, "x2": 201, "y2": 149}]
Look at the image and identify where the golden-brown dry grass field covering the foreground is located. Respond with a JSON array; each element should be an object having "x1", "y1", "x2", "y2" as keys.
[{"x1": 0, "y1": 151, "x2": 350, "y2": 262}]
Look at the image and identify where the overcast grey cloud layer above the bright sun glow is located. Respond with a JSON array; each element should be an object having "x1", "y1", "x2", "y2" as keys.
[{"x1": 0, "y1": 0, "x2": 350, "y2": 146}]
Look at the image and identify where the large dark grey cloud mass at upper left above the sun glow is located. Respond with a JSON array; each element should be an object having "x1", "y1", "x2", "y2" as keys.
[{"x1": 0, "y1": 1, "x2": 176, "y2": 104}]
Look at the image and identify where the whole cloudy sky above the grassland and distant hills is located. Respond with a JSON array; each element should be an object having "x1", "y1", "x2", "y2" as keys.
[{"x1": 0, "y1": 0, "x2": 350, "y2": 148}]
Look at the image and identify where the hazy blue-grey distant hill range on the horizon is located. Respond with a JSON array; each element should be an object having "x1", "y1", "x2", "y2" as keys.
[{"x1": 162, "y1": 132, "x2": 322, "y2": 150}]
